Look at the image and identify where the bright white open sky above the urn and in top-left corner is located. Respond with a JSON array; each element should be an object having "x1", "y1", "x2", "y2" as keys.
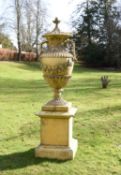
[{"x1": 0, "y1": 0, "x2": 83, "y2": 31}]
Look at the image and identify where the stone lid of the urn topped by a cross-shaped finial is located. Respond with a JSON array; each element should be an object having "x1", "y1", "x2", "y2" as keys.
[{"x1": 43, "y1": 17, "x2": 72, "y2": 39}]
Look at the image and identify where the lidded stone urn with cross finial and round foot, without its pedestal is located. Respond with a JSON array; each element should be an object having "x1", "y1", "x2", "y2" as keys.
[{"x1": 40, "y1": 18, "x2": 75, "y2": 111}]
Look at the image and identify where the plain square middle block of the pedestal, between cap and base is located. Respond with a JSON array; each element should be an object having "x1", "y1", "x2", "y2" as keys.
[{"x1": 40, "y1": 117, "x2": 73, "y2": 146}]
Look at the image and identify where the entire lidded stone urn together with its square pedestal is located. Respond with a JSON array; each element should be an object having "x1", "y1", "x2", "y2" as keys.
[{"x1": 35, "y1": 18, "x2": 77, "y2": 160}]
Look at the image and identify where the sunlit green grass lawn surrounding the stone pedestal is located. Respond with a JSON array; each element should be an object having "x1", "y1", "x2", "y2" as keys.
[{"x1": 0, "y1": 62, "x2": 121, "y2": 175}]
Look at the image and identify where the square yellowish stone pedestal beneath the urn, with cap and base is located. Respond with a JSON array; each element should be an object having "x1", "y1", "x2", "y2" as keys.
[{"x1": 35, "y1": 107, "x2": 77, "y2": 160}]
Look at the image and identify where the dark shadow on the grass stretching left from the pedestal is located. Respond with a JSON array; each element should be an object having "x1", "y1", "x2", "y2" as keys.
[{"x1": 0, "y1": 148, "x2": 65, "y2": 171}]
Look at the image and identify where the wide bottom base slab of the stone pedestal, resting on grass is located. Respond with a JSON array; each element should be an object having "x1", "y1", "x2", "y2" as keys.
[{"x1": 35, "y1": 139, "x2": 78, "y2": 160}]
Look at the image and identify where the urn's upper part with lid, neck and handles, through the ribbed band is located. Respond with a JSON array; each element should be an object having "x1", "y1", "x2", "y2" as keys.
[{"x1": 41, "y1": 18, "x2": 75, "y2": 58}]
